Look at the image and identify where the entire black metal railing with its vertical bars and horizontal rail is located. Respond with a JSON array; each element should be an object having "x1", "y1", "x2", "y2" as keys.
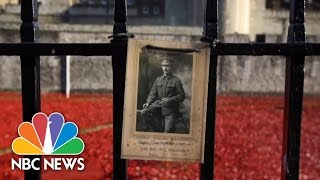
[{"x1": 0, "y1": 0, "x2": 320, "y2": 180}]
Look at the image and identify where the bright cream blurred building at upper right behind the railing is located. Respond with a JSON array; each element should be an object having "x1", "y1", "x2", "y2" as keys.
[{"x1": 224, "y1": 0, "x2": 320, "y2": 42}]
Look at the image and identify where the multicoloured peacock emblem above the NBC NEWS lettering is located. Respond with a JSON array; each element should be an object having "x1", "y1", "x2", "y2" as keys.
[{"x1": 11, "y1": 112, "x2": 84, "y2": 155}]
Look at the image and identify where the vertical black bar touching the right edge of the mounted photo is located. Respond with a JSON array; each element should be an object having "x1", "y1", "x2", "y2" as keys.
[{"x1": 200, "y1": 0, "x2": 218, "y2": 179}]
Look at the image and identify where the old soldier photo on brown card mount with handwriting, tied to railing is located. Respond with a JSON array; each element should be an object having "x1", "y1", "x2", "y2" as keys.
[{"x1": 122, "y1": 39, "x2": 210, "y2": 162}]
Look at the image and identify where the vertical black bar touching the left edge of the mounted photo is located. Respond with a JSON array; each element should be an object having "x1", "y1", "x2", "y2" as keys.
[{"x1": 111, "y1": 0, "x2": 128, "y2": 180}]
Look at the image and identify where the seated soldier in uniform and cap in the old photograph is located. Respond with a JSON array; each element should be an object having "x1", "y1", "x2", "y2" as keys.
[{"x1": 141, "y1": 58, "x2": 185, "y2": 133}]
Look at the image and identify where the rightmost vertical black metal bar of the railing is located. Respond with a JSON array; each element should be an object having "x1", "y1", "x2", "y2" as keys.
[{"x1": 281, "y1": 0, "x2": 305, "y2": 180}]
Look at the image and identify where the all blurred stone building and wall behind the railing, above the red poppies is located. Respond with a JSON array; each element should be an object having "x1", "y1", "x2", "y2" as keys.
[{"x1": 0, "y1": 0, "x2": 320, "y2": 94}]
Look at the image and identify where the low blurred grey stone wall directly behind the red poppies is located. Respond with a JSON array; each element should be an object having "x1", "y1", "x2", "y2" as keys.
[{"x1": 0, "y1": 23, "x2": 320, "y2": 94}]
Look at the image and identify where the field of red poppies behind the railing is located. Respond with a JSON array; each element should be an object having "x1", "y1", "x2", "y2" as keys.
[{"x1": 0, "y1": 92, "x2": 320, "y2": 180}]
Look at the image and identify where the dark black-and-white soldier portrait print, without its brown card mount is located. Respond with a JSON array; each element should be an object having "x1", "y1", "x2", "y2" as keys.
[{"x1": 136, "y1": 54, "x2": 192, "y2": 134}]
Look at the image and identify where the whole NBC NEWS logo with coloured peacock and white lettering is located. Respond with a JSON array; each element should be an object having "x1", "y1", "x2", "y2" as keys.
[{"x1": 11, "y1": 112, "x2": 85, "y2": 171}]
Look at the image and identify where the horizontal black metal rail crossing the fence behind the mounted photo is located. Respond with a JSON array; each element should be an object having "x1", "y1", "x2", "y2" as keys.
[{"x1": 0, "y1": 42, "x2": 320, "y2": 56}]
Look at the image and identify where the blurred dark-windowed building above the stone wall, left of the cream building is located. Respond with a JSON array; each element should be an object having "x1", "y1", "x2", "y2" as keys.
[{"x1": 0, "y1": 0, "x2": 204, "y2": 26}]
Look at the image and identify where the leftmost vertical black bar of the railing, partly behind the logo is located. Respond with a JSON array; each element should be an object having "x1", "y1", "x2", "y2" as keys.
[{"x1": 20, "y1": 0, "x2": 41, "y2": 180}]
